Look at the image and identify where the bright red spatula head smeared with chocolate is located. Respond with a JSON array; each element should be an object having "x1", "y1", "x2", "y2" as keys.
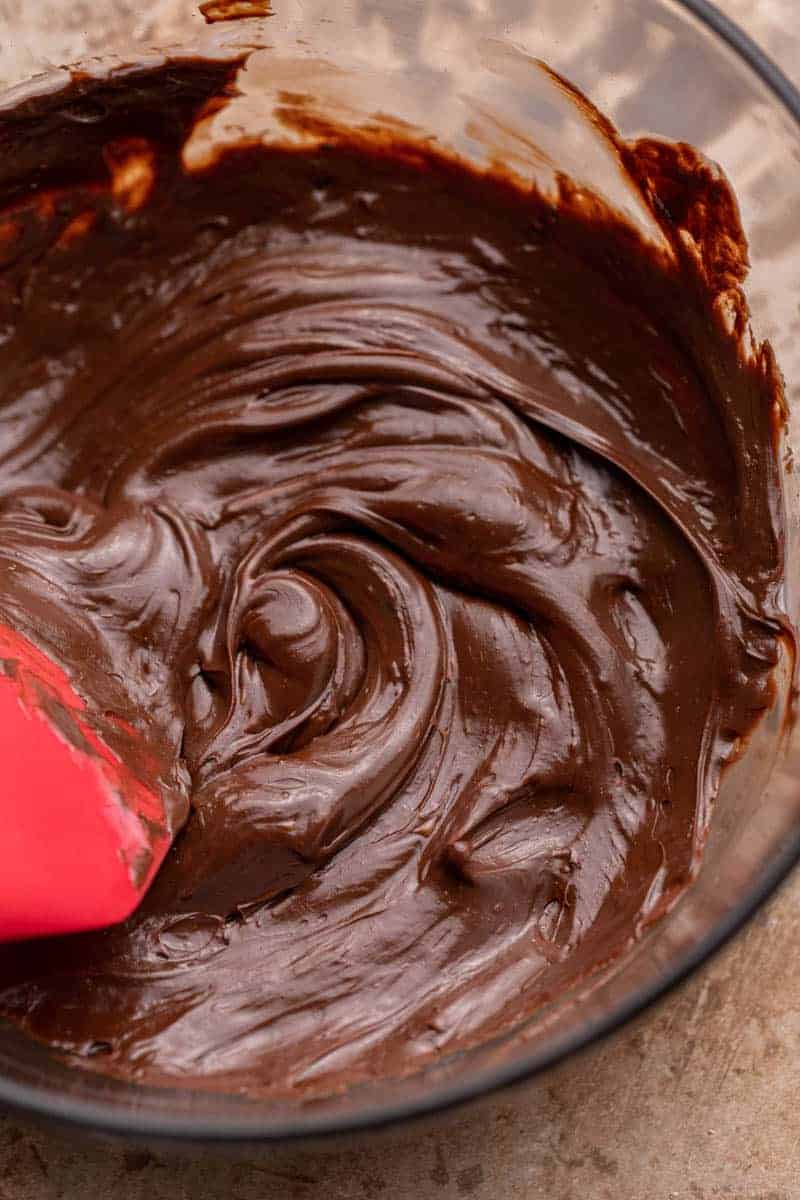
[{"x1": 0, "y1": 624, "x2": 172, "y2": 941}]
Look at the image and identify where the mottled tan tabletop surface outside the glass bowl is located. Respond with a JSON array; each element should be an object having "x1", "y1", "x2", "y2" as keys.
[{"x1": 0, "y1": 0, "x2": 800, "y2": 1200}]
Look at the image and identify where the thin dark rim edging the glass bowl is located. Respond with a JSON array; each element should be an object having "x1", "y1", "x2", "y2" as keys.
[{"x1": 0, "y1": 0, "x2": 800, "y2": 1146}]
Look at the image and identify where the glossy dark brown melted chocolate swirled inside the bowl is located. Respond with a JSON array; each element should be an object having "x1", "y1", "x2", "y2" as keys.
[{"x1": 0, "y1": 62, "x2": 783, "y2": 1093}]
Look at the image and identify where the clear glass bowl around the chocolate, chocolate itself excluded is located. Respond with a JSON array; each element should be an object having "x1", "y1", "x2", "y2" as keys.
[{"x1": 0, "y1": 0, "x2": 800, "y2": 1144}]
